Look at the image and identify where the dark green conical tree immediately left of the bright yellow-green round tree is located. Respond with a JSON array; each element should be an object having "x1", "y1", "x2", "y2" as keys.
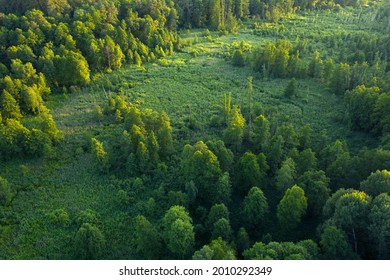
[{"x1": 242, "y1": 187, "x2": 268, "y2": 228}]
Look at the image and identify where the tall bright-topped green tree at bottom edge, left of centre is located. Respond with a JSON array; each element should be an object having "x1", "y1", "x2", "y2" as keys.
[{"x1": 162, "y1": 205, "x2": 195, "y2": 259}]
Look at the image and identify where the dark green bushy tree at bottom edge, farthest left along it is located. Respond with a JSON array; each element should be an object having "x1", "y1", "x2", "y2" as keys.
[{"x1": 75, "y1": 223, "x2": 105, "y2": 260}]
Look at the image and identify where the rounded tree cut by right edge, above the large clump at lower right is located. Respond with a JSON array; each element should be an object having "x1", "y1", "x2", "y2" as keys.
[{"x1": 360, "y1": 170, "x2": 390, "y2": 197}]
